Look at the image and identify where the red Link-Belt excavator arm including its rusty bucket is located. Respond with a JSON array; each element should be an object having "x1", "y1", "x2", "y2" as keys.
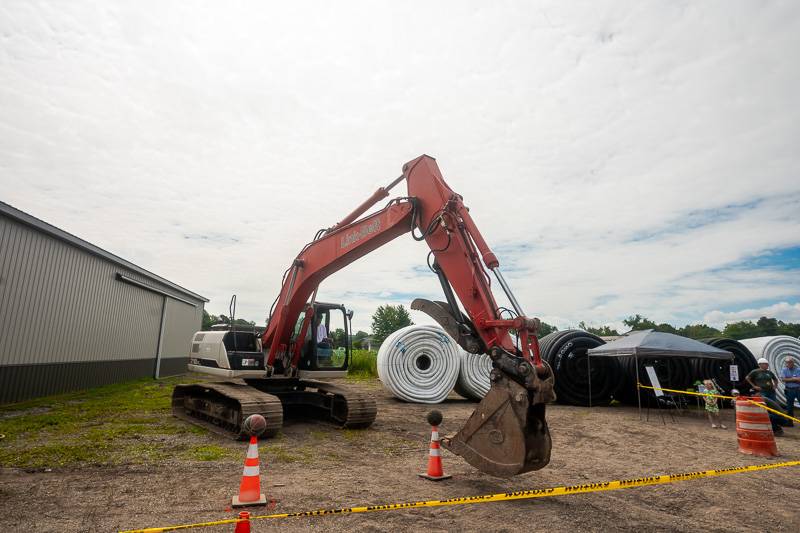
[{"x1": 262, "y1": 155, "x2": 555, "y2": 477}]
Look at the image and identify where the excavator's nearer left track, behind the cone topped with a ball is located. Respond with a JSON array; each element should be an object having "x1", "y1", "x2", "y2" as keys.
[{"x1": 172, "y1": 381, "x2": 283, "y2": 440}]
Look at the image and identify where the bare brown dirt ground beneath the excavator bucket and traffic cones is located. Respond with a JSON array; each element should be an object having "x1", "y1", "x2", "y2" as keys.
[{"x1": 0, "y1": 381, "x2": 800, "y2": 532}]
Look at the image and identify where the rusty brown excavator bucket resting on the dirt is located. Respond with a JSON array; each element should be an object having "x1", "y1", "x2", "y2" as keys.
[{"x1": 441, "y1": 368, "x2": 552, "y2": 477}]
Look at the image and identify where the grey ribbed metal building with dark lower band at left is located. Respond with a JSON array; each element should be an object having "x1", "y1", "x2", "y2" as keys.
[{"x1": 0, "y1": 202, "x2": 208, "y2": 402}]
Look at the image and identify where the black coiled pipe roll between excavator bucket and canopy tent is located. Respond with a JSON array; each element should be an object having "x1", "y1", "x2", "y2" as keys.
[{"x1": 539, "y1": 329, "x2": 620, "y2": 406}]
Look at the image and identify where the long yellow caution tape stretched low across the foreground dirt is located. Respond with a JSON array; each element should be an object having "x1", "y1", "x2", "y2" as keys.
[{"x1": 120, "y1": 461, "x2": 800, "y2": 533}]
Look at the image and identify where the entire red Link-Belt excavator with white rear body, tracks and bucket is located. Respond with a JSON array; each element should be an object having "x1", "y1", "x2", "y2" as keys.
[{"x1": 172, "y1": 155, "x2": 555, "y2": 477}]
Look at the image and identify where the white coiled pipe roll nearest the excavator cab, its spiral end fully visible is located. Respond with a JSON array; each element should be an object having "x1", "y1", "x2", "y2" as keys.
[{"x1": 378, "y1": 326, "x2": 460, "y2": 404}]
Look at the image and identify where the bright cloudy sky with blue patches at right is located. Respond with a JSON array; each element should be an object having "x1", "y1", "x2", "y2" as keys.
[{"x1": 0, "y1": 0, "x2": 800, "y2": 331}]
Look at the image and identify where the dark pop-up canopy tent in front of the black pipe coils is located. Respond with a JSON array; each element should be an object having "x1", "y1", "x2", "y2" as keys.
[{"x1": 587, "y1": 329, "x2": 734, "y2": 417}]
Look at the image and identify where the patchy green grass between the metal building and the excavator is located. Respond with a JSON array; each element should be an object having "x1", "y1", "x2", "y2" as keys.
[{"x1": 0, "y1": 378, "x2": 209, "y2": 468}]
